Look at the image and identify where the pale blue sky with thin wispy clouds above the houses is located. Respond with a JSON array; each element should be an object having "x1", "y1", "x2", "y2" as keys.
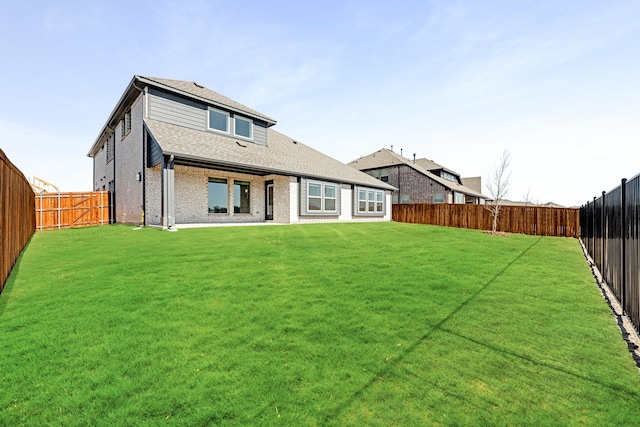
[{"x1": 0, "y1": 0, "x2": 640, "y2": 205}]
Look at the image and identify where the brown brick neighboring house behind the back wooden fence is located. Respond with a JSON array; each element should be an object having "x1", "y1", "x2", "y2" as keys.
[{"x1": 349, "y1": 148, "x2": 488, "y2": 204}]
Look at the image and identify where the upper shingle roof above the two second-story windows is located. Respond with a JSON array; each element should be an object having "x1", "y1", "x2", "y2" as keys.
[{"x1": 136, "y1": 76, "x2": 276, "y2": 125}]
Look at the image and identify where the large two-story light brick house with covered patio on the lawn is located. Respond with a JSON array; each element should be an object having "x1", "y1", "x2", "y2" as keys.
[{"x1": 88, "y1": 76, "x2": 394, "y2": 228}]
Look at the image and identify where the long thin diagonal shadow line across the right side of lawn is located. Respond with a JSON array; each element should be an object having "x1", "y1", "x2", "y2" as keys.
[{"x1": 324, "y1": 236, "x2": 542, "y2": 422}]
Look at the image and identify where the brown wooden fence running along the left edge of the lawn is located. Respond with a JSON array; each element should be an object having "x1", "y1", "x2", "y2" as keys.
[{"x1": 0, "y1": 149, "x2": 36, "y2": 292}]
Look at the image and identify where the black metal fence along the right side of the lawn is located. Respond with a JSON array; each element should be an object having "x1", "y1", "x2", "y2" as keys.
[{"x1": 580, "y1": 174, "x2": 640, "y2": 338}]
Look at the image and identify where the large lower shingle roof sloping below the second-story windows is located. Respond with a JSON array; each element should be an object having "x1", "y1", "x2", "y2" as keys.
[{"x1": 144, "y1": 119, "x2": 395, "y2": 190}]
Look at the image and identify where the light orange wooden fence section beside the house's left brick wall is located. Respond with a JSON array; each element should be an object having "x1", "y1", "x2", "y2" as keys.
[{"x1": 35, "y1": 191, "x2": 109, "y2": 230}]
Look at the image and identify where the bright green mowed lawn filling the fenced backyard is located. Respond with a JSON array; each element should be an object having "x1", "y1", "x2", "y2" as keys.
[{"x1": 0, "y1": 223, "x2": 640, "y2": 426}]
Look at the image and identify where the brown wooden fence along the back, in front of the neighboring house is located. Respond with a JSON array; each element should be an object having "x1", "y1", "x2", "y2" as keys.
[{"x1": 392, "y1": 203, "x2": 580, "y2": 237}]
